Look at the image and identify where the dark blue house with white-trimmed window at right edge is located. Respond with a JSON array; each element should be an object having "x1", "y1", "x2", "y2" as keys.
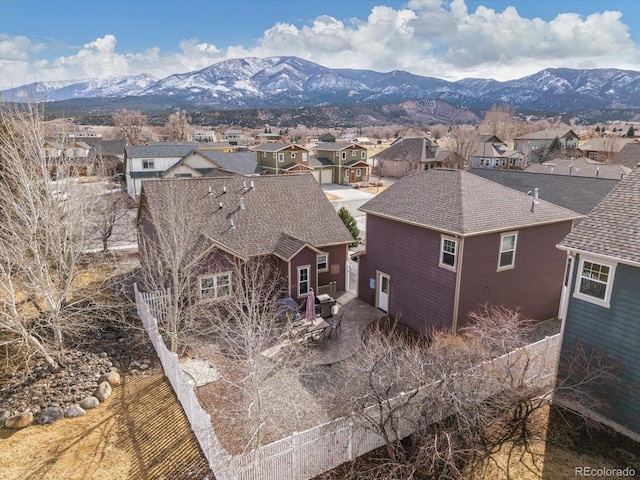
[{"x1": 558, "y1": 166, "x2": 640, "y2": 441}]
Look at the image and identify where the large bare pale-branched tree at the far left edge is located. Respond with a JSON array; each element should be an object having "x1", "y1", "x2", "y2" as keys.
[{"x1": 0, "y1": 105, "x2": 99, "y2": 371}]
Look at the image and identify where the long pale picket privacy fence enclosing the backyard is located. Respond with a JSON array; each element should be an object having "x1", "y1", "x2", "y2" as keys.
[{"x1": 134, "y1": 285, "x2": 560, "y2": 480}]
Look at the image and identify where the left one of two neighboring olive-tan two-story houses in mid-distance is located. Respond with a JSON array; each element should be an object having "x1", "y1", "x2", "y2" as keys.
[{"x1": 253, "y1": 142, "x2": 313, "y2": 175}]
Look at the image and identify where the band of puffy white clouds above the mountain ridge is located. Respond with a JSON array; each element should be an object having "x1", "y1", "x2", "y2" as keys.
[{"x1": 0, "y1": 0, "x2": 640, "y2": 87}]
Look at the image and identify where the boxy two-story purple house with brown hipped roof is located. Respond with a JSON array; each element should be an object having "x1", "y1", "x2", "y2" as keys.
[{"x1": 358, "y1": 168, "x2": 582, "y2": 333}]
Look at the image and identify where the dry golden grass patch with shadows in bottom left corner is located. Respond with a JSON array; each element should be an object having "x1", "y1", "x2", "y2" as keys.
[{"x1": 0, "y1": 372, "x2": 213, "y2": 480}]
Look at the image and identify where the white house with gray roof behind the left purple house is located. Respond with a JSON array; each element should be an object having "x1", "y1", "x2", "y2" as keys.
[{"x1": 124, "y1": 142, "x2": 261, "y2": 198}]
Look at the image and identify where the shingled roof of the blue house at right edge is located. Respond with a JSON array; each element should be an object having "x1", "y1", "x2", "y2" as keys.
[{"x1": 559, "y1": 167, "x2": 640, "y2": 266}]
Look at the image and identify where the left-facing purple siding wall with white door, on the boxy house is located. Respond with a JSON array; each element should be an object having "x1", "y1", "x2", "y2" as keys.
[{"x1": 358, "y1": 214, "x2": 456, "y2": 333}]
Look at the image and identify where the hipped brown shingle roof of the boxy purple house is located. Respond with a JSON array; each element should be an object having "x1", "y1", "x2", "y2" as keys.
[{"x1": 360, "y1": 168, "x2": 581, "y2": 235}]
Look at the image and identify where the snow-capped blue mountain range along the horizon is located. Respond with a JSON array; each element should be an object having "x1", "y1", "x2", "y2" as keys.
[{"x1": 0, "y1": 57, "x2": 640, "y2": 112}]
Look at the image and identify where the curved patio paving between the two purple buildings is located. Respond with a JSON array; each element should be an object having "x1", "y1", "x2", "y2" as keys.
[{"x1": 307, "y1": 292, "x2": 385, "y2": 365}]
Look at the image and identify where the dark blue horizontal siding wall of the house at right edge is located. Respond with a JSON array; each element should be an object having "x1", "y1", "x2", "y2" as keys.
[{"x1": 562, "y1": 257, "x2": 640, "y2": 434}]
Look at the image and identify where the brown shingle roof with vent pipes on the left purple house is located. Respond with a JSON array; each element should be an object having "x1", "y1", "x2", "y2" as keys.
[{"x1": 142, "y1": 174, "x2": 353, "y2": 258}]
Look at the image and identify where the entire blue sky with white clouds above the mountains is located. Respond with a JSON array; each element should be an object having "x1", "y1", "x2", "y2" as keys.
[{"x1": 0, "y1": 0, "x2": 640, "y2": 88}]
